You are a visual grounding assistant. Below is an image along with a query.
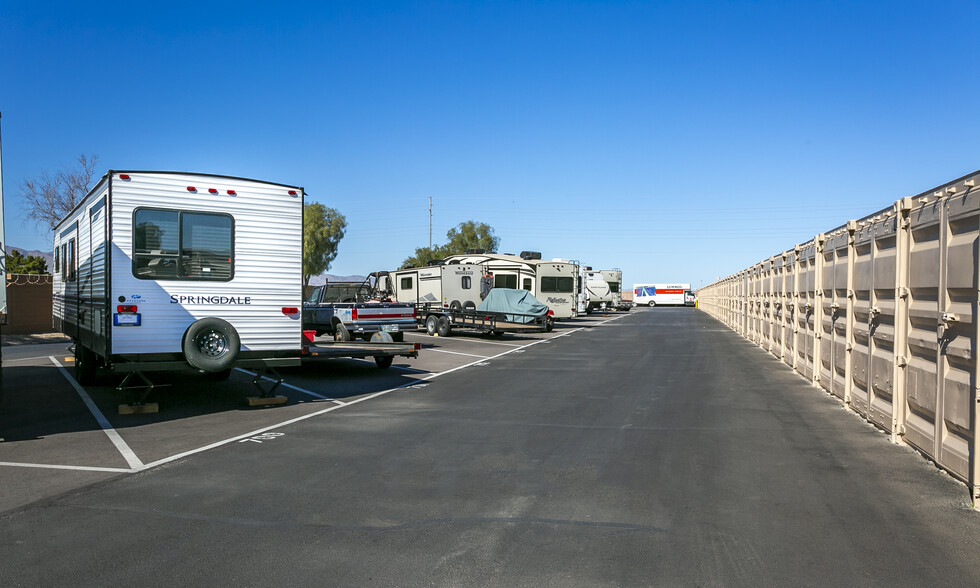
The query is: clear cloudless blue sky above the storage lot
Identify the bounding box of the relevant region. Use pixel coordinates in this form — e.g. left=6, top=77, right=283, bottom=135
left=0, top=0, right=980, bottom=287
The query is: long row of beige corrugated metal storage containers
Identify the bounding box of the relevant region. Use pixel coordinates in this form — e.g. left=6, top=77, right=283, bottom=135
left=698, top=171, right=980, bottom=505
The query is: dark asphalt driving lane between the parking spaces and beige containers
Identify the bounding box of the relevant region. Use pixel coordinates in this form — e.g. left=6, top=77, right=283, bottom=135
left=0, top=308, right=980, bottom=586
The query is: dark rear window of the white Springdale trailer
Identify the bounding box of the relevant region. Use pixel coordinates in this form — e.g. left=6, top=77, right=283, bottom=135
left=133, top=208, right=235, bottom=282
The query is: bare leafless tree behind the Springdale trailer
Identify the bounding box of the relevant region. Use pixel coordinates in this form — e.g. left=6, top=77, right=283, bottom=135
left=21, top=155, right=99, bottom=229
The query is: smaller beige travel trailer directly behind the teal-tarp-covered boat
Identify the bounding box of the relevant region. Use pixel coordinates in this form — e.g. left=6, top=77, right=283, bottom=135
left=378, top=262, right=493, bottom=310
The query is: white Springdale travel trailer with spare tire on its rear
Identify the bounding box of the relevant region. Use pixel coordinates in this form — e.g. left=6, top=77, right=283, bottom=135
left=53, top=171, right=305, bottom=383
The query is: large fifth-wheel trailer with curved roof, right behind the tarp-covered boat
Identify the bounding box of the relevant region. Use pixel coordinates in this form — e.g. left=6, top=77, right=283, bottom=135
left=445, top=251, right=578, bottom=319
